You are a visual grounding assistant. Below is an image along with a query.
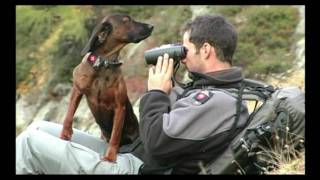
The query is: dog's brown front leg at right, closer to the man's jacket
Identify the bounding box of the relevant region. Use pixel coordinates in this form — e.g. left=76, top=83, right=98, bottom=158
left=103, top=106, right=126, bottom=162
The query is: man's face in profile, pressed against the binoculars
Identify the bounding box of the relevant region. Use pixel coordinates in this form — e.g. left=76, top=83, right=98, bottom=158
left=181, top=31, right=201, bottom=72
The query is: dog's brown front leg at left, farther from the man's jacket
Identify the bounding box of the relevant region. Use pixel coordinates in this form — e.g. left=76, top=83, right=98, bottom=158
left=60, top=84, right=83, bottom=140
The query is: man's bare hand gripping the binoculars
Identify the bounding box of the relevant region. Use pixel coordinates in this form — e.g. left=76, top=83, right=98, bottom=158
left=148, top=54, right=173, bottom=94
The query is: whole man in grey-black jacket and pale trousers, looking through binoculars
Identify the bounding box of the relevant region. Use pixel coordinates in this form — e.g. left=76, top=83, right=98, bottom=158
left=16, top=16, right=248, bottom=174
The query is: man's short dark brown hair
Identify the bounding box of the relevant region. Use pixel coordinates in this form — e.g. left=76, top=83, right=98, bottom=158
left=183, top=15, right=237, bottom=64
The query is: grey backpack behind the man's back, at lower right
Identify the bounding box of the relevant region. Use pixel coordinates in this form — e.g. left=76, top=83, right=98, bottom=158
left=200, top=79, right=305, bottom=174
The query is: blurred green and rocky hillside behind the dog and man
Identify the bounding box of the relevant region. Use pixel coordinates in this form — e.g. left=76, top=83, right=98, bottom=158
left=16, top=5, right=305, bottom=139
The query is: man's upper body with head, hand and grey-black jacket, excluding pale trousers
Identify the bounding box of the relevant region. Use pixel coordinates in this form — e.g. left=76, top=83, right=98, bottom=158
left=133, top=16, right=248, bottom=174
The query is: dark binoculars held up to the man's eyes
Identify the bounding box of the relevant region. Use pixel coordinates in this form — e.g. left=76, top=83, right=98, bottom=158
left=144, top=44, right=187, bottom=65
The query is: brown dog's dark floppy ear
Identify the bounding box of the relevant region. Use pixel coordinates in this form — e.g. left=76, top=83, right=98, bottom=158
left=81, top=21, right=112, bottom=56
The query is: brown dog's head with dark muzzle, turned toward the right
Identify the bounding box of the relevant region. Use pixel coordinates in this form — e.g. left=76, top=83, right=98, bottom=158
left=81, top=14, right=153, bottom=55
